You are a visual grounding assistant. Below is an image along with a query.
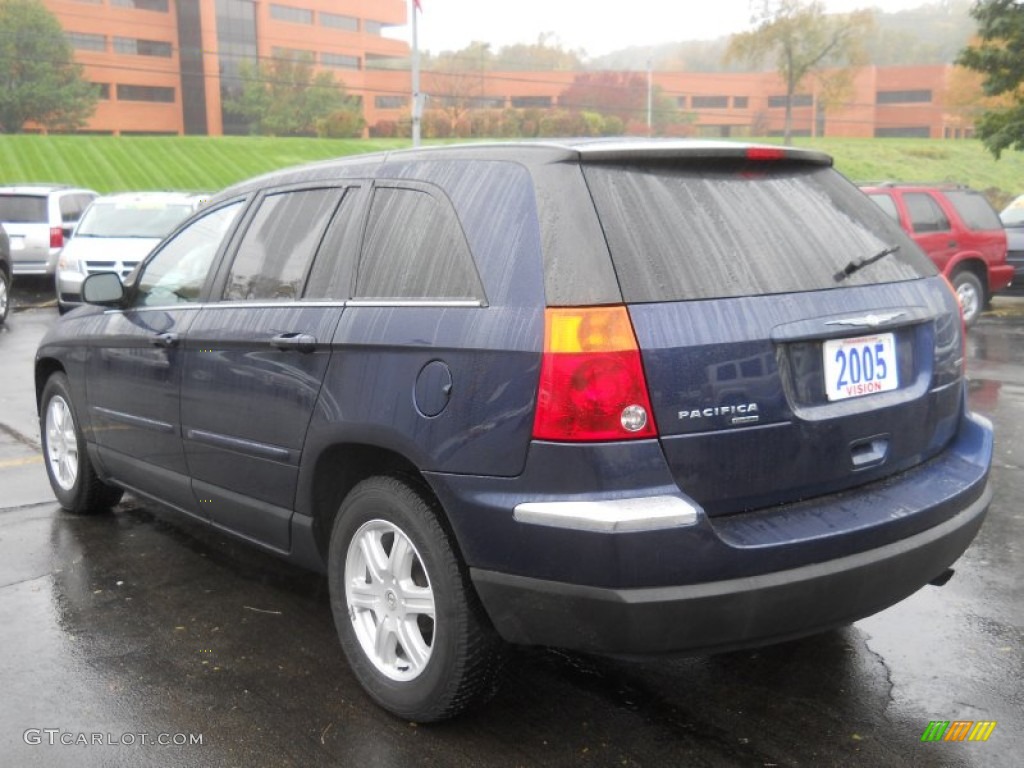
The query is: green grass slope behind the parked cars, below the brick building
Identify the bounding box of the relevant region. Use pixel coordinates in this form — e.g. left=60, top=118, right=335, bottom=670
left=0, top=135, right=1024, bottom=207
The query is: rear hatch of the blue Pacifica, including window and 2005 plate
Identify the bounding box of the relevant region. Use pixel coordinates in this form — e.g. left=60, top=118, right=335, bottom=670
left=583, top=147, right=963, bottom=515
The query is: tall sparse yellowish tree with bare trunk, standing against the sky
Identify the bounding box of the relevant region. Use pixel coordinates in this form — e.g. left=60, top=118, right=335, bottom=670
left=726, top=0, right=874, bottom=142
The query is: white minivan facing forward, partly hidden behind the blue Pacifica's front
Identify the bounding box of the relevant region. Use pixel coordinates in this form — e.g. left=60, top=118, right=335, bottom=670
left=55, top=191, right=205, bottom=313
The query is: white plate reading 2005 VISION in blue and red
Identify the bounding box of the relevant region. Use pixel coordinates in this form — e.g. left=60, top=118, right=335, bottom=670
left=822, top=334, right=899, bottom=400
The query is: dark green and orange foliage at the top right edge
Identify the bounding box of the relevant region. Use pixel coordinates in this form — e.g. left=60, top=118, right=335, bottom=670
left=957, top=0, right=1024, bottom=160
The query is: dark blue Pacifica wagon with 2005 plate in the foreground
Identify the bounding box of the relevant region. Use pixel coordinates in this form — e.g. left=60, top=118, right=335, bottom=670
left=36, top=140, right=992, bottom=721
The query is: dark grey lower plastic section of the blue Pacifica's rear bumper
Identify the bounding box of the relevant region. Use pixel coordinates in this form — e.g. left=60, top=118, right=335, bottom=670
left=471, top=485, right=991, bottom=654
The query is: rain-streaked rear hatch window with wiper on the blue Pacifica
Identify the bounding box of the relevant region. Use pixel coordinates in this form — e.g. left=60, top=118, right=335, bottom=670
left=584, top=161, right=935, bottom=302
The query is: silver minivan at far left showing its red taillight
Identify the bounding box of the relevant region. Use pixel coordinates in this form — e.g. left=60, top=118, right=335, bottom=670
left=0, top=184, right=97, bottom=276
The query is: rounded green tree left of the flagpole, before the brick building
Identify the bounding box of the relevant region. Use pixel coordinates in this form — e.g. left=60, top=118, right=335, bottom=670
left=224, top=54, right=362, bottom=136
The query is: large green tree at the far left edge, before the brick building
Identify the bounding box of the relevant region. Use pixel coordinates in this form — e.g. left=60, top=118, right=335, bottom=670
left=0, top=0, right=99, bottom=133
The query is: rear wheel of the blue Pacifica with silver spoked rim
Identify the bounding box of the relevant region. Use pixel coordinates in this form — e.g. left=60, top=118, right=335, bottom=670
left=328, top=476, right=502, bottom=722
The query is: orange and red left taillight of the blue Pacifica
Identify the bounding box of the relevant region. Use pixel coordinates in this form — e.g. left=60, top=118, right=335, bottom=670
left=534, top=306, right=657, bottom=441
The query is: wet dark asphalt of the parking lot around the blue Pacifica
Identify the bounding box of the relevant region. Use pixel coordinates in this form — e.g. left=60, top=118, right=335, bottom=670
left=0, top=285, right=1024, bottom=768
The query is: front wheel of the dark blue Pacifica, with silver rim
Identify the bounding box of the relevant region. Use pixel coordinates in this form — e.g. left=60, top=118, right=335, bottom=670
left=39, top=373, right=124, bottom=514
